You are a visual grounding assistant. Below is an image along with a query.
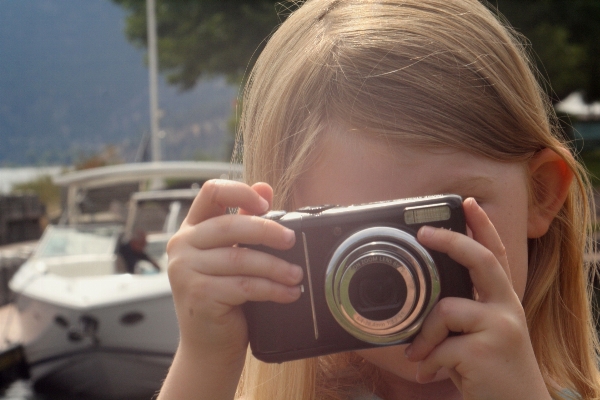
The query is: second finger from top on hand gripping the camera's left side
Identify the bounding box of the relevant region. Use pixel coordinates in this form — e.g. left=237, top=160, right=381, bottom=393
left=181, top=214, right=296, bottom=250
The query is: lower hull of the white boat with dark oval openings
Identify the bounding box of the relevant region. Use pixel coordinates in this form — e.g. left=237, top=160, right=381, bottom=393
left=17, top=278, right=179, bottom=399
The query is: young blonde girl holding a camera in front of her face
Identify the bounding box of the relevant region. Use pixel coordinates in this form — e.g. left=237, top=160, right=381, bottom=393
left=159, top=0, right=600, bottom=400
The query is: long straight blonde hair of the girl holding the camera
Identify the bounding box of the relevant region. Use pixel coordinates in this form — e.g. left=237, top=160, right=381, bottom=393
left=233, top=0, right=600, bottom=400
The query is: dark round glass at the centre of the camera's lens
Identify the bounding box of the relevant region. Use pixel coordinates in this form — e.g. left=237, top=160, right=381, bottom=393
left=348, top=263, right=406, bottom=321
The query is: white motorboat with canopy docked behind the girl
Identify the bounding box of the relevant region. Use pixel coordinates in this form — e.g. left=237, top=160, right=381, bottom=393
left=10, top=163, right=239, bottom=399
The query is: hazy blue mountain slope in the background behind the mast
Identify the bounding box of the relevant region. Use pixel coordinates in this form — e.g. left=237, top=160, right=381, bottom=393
left=0, top=0, right=238, bottom=166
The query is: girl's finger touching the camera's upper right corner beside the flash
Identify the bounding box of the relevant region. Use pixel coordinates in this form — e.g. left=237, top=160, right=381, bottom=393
left=463, top=198, right=512, bottom=282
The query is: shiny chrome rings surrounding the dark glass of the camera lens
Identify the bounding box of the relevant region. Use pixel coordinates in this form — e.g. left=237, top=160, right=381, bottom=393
left=325, top=227, right=440, bottom=344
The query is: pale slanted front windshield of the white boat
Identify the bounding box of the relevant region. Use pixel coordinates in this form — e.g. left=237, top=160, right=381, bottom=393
left=36, top=226, right=120, bottom=257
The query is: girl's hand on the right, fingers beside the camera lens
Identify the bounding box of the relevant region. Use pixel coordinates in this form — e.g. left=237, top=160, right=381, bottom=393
left=406, top=198, right=550, bottom=400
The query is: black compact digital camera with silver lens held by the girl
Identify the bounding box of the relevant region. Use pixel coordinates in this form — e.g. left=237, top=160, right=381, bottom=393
left=244, top=195, right=473, bottom=362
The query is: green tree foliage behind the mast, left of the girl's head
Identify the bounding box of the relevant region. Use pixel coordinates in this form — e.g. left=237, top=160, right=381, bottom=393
left=113, top=0, right=290, bottom=90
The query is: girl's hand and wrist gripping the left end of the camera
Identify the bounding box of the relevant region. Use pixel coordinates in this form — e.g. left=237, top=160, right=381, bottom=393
left=158, top=180, right=302, bottom=399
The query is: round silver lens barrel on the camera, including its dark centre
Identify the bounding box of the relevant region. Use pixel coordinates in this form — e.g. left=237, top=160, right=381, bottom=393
left=325, top=227, right=440, bottom=345
